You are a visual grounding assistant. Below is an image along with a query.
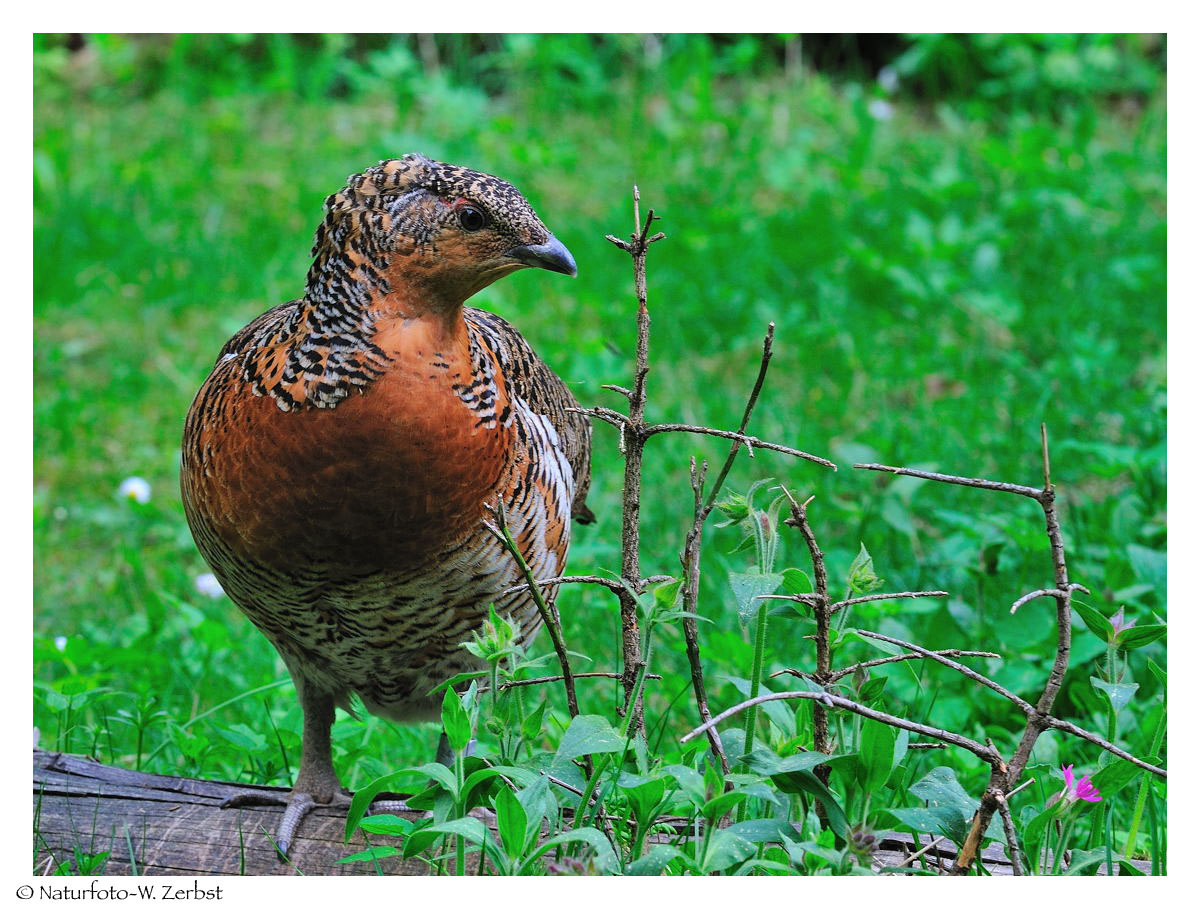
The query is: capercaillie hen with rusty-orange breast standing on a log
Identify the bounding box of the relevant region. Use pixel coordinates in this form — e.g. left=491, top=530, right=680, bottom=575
left=180, top=155, right=592, bottom=851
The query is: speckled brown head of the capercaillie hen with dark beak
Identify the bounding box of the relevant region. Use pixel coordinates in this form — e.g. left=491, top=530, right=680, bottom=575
left=308, top=155, right=576, bottom=308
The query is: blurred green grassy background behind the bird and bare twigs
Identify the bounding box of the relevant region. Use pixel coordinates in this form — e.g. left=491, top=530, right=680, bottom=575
left=34, top=35, right=1166, bottom=787
